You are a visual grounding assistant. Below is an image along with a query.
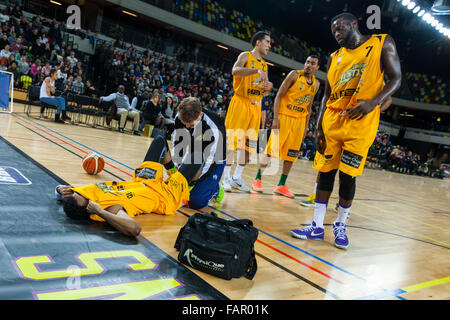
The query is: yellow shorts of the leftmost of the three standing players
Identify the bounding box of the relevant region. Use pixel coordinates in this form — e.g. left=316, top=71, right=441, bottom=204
left=225, top=95, right=261, bottom=153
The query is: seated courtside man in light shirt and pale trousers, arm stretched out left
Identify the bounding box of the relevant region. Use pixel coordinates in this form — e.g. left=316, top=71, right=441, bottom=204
left=100, top=85, right=141, bottom=136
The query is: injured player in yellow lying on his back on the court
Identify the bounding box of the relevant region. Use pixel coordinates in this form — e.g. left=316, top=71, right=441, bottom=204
left=55, top=136, right=202, bottom=237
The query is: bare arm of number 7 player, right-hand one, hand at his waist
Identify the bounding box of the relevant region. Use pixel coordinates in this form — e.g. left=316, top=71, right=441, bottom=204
left=347, top=35, right=402, bottom=120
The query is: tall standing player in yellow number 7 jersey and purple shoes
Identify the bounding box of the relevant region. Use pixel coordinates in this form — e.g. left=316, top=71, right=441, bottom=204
left=291, top=13, right=401, bottom=249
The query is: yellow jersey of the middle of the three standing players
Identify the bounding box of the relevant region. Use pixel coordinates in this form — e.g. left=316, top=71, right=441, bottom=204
left=279, top=70, right=316, bottom=118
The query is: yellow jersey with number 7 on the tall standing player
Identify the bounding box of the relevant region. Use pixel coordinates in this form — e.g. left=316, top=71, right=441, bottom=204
left=327, top=34, right=387, bottom=110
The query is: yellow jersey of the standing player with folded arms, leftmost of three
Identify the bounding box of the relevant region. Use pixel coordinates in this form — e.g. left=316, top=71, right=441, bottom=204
left=233, top=51, right=267, bottom=103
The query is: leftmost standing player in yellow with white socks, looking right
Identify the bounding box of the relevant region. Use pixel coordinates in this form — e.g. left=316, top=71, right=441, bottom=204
left=222, top=31, right=273, bottom=192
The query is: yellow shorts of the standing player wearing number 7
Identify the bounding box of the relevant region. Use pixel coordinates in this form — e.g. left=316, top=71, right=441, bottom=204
left=313, top=107, right=380, bottom=177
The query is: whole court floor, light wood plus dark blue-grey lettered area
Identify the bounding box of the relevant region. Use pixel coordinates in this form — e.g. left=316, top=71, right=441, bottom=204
left=0, top=103, right=450, bottom=300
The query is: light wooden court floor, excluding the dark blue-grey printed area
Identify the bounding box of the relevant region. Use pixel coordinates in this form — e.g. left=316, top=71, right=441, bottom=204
left=0, top=103, right=450, bottom=300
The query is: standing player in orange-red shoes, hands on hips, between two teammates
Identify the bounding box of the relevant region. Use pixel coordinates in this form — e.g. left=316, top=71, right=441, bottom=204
left=252, top=56, right=320, bottom=198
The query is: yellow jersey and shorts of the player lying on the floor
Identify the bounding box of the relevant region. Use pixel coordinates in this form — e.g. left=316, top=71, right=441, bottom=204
left=72, top=161, right=189, bottom=221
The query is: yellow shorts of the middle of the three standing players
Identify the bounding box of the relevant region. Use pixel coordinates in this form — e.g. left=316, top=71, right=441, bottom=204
left=264, top=114, right=306, bottom=162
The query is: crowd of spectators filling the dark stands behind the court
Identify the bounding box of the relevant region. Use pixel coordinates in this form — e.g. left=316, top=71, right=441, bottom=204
left=0, top=0, right=448, bottom=176
